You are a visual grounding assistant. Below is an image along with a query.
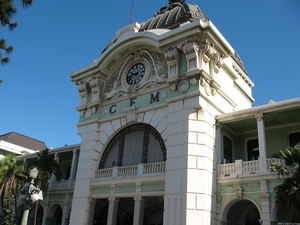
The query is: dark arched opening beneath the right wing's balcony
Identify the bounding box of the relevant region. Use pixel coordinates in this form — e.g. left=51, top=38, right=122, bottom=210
left=225, top=200, right=260, bottom=225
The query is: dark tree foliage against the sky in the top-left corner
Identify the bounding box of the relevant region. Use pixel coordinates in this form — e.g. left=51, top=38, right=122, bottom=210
left=0, top=0, right=33, bottom=65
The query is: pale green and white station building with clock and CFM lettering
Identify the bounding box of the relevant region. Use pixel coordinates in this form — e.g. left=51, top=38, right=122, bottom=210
left=5, top=0, right=300, bottom=225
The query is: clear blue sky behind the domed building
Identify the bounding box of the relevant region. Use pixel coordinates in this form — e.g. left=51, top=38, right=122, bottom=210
left=0, top=0, right=300, bottom=148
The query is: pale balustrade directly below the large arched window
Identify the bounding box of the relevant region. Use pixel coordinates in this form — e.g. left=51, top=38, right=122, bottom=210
left=95, top=162, right=166, bottom=180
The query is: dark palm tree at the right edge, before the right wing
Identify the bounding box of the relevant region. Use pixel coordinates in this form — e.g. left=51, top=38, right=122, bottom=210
left=270, top=144, right=300, bottom=223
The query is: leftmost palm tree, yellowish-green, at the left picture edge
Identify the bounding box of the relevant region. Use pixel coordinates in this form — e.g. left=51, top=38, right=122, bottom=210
left=0, top=155, right=27, bottom=224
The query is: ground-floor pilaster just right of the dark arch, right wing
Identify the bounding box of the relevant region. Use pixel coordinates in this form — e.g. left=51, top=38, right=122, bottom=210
left=260, top=180, right=271, bottom=225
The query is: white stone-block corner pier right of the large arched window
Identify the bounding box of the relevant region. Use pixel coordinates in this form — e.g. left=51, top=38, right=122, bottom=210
left=164, top=97, right=214, bottom=225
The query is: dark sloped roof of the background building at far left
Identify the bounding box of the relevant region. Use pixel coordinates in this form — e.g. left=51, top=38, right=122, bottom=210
left=0, top=132, right=47, bottom=150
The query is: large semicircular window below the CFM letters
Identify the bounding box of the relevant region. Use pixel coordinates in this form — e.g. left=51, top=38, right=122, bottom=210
left=99, top=124, right=166, bottom=169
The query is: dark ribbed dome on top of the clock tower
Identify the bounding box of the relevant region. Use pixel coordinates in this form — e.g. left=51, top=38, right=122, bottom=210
left=139, top=0, right=208, bottom=31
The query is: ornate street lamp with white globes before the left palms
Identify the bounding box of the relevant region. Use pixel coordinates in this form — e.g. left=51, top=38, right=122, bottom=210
left=21, top=167, right=42, bottom=225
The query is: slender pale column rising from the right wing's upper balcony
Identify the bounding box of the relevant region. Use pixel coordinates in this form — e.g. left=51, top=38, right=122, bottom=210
left=255, top=113, right=268, bottom=173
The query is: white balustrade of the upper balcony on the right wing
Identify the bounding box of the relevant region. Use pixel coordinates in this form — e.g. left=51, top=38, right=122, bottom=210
left=218, top=158, right=281, bottom=178
